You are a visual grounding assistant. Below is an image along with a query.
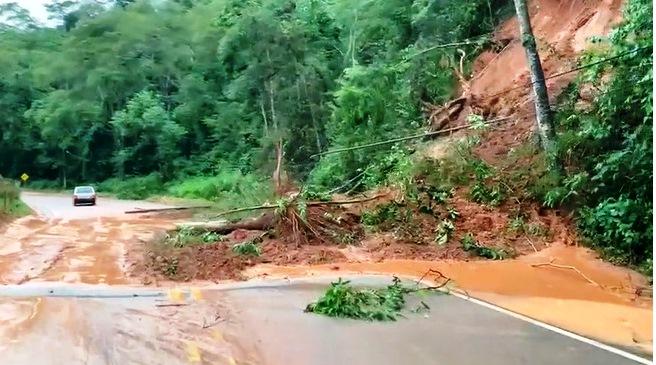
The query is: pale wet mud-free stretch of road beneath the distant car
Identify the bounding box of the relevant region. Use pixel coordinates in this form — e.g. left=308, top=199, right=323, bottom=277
left=21, top=191, right=172, bottom=220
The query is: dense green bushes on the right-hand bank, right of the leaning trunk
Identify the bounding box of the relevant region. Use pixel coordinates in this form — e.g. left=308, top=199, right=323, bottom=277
left=542, top=0, right=653, bottom=276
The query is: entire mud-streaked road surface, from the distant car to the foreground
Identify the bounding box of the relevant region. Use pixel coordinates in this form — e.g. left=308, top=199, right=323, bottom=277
left=0, top=193, right=649, bottom=365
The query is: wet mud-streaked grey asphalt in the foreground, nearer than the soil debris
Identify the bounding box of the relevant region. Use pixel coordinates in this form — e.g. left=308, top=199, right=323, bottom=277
left=0, top=277, right=638, bottom=365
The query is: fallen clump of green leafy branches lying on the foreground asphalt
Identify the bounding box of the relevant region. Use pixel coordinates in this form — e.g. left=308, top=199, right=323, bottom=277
left=305, top=270, right=450, bottom=321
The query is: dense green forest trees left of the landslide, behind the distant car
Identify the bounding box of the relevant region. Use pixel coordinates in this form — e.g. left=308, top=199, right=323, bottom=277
left=0, top=0, right=506, bottom=182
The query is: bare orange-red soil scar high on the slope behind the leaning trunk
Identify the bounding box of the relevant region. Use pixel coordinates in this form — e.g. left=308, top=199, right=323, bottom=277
left=436, top=0, right=622, bottom=163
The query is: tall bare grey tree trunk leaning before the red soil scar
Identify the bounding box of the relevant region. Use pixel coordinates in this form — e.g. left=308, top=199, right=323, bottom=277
left=514, top=0, right=555, bottom=154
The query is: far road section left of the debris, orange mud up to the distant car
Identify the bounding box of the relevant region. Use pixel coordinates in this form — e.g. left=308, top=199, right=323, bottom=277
left=0, top=192, right=171, bottom=284
